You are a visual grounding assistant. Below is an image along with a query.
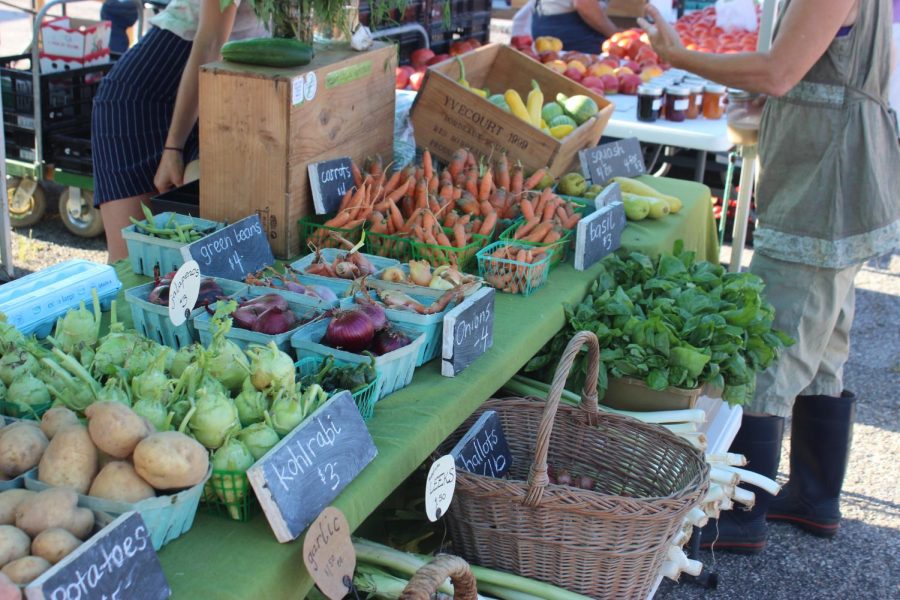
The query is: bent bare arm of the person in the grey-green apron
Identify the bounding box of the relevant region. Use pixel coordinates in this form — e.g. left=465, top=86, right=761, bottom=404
left=638, top=0, right=858, bottom=96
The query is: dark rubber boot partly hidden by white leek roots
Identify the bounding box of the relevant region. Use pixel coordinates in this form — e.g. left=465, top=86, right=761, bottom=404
left=700, top=415, right=784, bottom=554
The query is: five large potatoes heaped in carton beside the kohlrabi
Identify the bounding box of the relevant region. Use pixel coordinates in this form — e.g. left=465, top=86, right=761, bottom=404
left=34, top=402, right=209, bottom=502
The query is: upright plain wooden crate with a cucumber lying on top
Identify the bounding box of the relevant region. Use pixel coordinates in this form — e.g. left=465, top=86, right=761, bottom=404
left=200, top=42, right=397, bottom=258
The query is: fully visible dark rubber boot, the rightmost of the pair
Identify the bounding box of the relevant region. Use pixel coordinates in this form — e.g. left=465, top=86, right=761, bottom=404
left=768, top=391, right=856, bottom=538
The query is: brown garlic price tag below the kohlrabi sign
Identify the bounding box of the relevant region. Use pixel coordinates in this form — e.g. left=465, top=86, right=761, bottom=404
left=303, top=506, right=356, bottom=600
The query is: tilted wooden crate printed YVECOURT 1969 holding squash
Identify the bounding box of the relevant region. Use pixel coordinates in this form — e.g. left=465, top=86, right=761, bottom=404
left=410, top=44, right=613, bottom=176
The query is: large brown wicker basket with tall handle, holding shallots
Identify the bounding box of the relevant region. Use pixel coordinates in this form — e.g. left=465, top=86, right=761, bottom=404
left=442, top=331, right=709, bottom=600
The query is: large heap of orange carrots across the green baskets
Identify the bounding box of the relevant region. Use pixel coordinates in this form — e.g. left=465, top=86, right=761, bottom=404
left=312, top=148, right=577, bottom=260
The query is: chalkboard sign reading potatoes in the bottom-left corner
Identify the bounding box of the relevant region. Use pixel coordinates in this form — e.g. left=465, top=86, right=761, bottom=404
left=25, top=511, right=172, bottom=600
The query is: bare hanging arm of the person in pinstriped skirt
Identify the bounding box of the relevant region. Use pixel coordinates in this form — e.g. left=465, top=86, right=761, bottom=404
left=153, top=0, right=237, bottom=192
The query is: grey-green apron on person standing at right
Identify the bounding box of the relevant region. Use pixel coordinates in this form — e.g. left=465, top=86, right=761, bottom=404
left=754, top=0, right=900, bottom=269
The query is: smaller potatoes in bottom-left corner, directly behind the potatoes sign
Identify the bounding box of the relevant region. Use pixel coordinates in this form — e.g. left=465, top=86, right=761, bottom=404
left=0, top=488, right=94, bottom=599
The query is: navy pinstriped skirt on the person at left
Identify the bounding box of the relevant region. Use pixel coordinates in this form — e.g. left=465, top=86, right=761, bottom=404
left=91, top=28, right=199, bottom=206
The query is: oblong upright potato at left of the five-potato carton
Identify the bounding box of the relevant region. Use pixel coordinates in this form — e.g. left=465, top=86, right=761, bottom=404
left=38, top=425, right=97, bottom=494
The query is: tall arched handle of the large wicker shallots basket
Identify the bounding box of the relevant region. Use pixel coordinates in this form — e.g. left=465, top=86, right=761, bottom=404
left=525, top=331, right=600, bottom=506
